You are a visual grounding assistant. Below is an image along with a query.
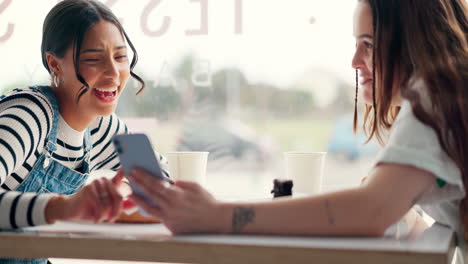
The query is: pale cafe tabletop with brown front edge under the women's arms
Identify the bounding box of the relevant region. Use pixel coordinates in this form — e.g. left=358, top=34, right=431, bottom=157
left=0, top=219, right=455, bottom=264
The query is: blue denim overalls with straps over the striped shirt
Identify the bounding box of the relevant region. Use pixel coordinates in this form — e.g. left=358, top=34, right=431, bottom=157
left=0, top=86, right=92, bottom=264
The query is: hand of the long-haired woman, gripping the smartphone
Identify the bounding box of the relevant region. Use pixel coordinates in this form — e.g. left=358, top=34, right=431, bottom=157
left=126, top=169, right=225, bottom=234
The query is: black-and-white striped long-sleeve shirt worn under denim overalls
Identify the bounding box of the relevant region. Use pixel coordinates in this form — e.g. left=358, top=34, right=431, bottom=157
left=0, top=88, right=167, bottom=229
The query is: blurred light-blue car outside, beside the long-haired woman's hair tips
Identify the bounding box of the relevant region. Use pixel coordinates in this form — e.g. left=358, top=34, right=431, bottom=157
left=327, top=115, right=379, bottom=160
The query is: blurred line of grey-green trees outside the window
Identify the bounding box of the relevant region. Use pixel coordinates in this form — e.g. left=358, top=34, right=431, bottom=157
left=117, top=54, right=326, bottom=120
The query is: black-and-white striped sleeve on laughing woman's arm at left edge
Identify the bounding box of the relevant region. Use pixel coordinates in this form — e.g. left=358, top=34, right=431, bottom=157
left=0, top=93, right=54, bottom=229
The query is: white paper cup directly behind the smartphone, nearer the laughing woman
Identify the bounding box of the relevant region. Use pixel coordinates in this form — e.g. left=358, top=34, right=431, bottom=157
left=167, top=152, right=209, bottom=185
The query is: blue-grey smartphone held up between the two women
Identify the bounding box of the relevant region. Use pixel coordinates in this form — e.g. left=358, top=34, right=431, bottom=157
left=112, top=134, right=173, bottom=207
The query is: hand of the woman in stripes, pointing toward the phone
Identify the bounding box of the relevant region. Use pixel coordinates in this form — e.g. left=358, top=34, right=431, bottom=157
left=45, top=173, right=123, bottom=224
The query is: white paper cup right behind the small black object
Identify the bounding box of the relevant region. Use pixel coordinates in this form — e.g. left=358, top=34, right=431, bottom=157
left=284, top=152, right=327, bottom=195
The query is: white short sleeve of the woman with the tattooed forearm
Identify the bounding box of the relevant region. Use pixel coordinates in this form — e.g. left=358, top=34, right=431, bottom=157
left=377, top=100, right=465, bottom=203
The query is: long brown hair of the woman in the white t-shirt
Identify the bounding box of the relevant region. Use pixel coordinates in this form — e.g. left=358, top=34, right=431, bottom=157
left=356, top=0, right=468, bottom=235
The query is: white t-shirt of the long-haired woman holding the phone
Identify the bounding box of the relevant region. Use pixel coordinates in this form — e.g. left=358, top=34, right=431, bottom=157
left=376, top=80, right=465, bottom=232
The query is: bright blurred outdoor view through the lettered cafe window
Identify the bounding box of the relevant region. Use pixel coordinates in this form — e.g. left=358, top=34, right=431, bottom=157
left=0, top=0, right=378, bottom=197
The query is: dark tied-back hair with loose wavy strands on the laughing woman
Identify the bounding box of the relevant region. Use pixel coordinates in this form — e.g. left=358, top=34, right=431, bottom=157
left=41, top=0, right=145, bottom=100
